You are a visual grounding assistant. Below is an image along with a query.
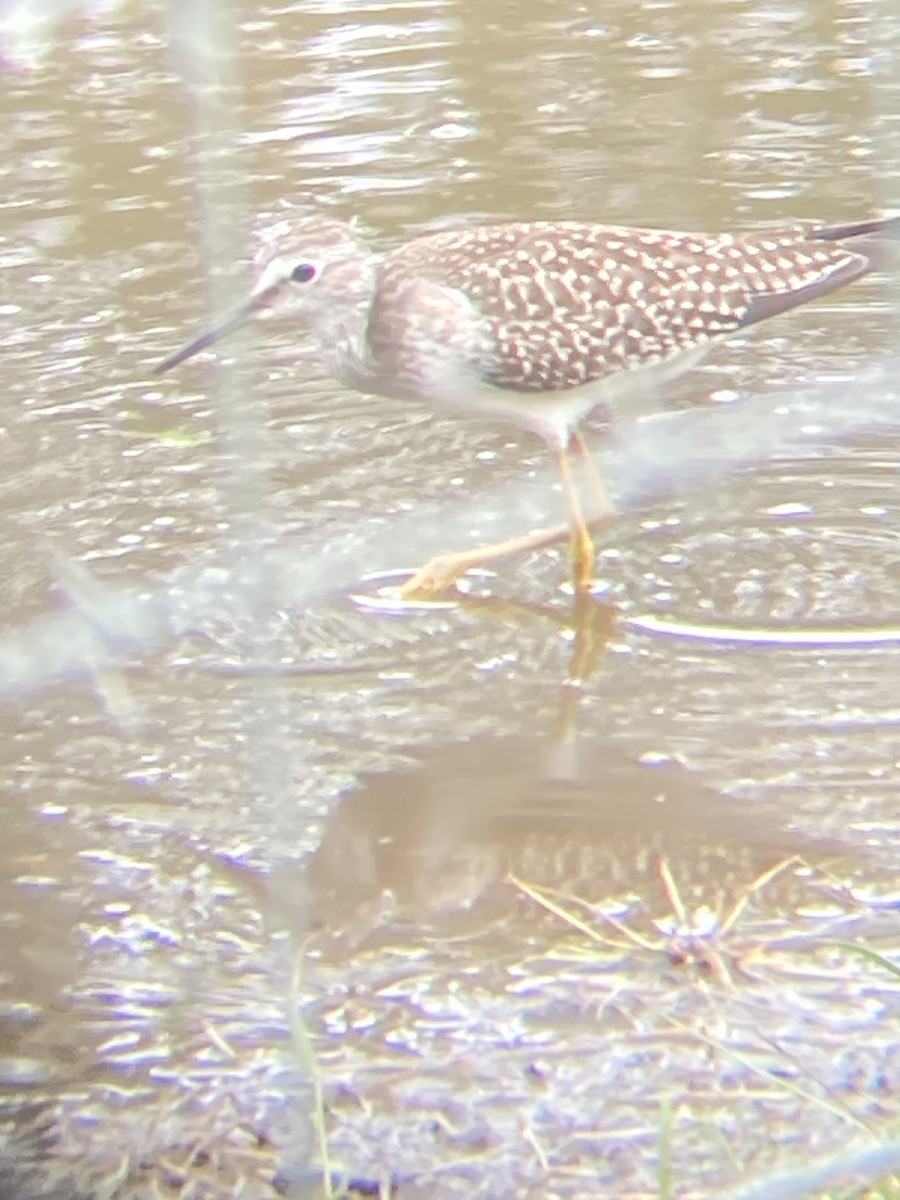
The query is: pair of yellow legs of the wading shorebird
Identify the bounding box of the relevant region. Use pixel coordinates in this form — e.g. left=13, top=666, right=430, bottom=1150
left=401, top=434, right=616, bottom=600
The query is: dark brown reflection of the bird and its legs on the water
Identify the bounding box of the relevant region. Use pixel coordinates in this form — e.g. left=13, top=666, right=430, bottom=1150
left=289, top=598, right=846, bottom=960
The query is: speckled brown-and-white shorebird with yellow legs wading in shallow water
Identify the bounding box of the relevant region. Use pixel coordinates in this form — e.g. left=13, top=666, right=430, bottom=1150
left=156, top=216, right=900, bottom=599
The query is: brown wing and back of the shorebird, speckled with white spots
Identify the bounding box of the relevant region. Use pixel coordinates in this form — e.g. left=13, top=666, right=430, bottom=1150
left=368, top=222, right=871, bottom=391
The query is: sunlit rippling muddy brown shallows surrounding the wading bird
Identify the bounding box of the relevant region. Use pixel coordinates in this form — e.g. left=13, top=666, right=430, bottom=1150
left=0, top=0, right=900, bottom=1198
